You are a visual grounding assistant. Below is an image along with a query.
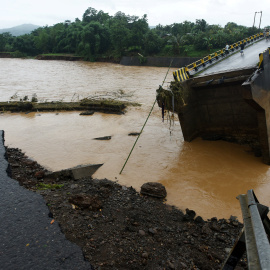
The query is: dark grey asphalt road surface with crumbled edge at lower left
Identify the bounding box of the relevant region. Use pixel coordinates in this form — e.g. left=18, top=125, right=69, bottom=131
left=0, top=130, right=92, bottom=270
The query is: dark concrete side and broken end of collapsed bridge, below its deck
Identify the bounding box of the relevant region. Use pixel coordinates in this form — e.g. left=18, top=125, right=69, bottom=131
left=157, top=36, right=270, bottom=164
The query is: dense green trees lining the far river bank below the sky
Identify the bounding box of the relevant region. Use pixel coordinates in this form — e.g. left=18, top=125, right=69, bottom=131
left=0, top=7, right=266, bottom=61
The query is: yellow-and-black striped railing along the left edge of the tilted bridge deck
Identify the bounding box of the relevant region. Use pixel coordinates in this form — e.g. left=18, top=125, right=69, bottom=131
left=173, top=33, right=264, bottom=81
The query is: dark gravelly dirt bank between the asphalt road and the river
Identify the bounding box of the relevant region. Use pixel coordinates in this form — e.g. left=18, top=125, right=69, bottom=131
left=7, top=148, right=247, bottom=270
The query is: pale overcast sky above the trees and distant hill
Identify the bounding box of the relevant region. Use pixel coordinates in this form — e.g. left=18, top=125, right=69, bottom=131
left=0, top=0, right=270, bottom=29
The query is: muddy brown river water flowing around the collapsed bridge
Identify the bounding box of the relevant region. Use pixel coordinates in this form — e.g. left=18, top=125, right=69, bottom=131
left=0, top=59, right=270, bottom=220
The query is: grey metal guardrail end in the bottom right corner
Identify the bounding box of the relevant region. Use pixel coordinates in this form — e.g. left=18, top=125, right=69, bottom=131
left=221, top=189, right=270, bottom=270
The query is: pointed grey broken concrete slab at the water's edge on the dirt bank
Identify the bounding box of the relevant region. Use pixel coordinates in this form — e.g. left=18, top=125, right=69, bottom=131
left=45, top=164, right=103, bottom=180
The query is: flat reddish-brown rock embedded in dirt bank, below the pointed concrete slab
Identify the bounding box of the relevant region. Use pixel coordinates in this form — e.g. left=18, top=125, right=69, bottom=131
left=68, top=194, right=102, bottom=211
